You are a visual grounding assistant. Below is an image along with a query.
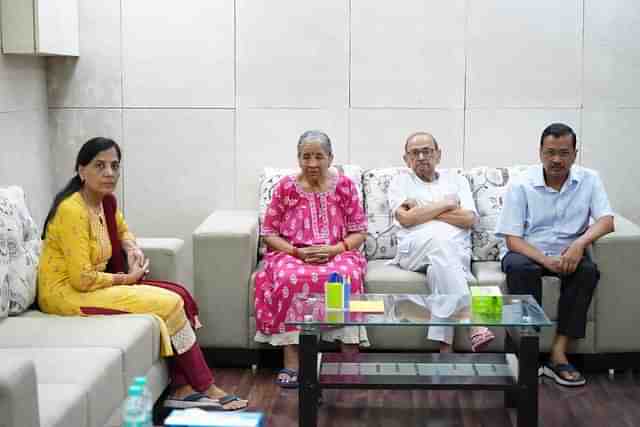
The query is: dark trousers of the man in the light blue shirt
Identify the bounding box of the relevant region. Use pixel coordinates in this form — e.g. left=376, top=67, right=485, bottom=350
left=502, top=252, right=600, bottom=338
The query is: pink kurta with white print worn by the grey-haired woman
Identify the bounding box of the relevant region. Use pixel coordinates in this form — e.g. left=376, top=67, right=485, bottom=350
left=255, top=175, right=367, bottom=335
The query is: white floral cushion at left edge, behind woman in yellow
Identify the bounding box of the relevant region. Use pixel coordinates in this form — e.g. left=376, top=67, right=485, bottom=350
left=0, top=187, right=41, bottom=318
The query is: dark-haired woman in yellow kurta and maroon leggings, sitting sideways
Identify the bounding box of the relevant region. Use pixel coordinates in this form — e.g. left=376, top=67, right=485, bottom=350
left=38, top=138, right=247, bottom=410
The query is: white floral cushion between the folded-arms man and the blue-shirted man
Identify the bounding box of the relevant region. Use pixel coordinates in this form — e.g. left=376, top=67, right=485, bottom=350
left=464, top=165, right=529, bottom=261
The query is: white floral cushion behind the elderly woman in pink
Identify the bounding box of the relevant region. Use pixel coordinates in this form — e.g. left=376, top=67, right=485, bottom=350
left=258, top=165, right=363, bottom=257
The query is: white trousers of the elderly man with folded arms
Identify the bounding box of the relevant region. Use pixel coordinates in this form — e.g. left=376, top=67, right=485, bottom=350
left=395, top=227, right=471, bottom=344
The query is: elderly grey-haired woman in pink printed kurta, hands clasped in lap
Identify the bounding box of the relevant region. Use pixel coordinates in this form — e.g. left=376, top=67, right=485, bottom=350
left=255, top=131, right=368, bottom=388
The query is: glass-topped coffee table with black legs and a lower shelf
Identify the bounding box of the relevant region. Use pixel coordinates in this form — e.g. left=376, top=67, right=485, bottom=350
left=286, top=294, right=552, bottom=427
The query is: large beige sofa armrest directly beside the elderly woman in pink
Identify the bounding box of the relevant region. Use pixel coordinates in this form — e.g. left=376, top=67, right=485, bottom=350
left=193, top=210, right=258, bottom=348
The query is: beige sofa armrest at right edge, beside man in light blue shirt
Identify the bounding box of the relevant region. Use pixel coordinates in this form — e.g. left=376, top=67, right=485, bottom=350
left=592, top=215, right=640, bottom=353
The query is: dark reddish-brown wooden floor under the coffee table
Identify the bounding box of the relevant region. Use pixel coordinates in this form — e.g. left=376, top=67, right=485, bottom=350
left=206, top=368, right=640, bottom=427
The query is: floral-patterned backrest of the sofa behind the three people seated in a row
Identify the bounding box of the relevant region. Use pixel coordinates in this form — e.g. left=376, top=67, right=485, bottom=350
left=255, top=165, right=529, bottom=261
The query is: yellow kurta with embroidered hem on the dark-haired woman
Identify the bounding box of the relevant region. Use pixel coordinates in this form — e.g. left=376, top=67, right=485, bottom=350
left=38, top=193, right=195, bottom=356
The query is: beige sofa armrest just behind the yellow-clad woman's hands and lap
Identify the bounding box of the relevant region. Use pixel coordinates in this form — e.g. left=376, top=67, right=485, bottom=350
left=137, top=238, right=184, bottom=282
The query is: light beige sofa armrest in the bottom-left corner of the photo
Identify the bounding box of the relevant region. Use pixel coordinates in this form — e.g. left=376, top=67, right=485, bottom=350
left=0, top=358, right=40, bottom=427
